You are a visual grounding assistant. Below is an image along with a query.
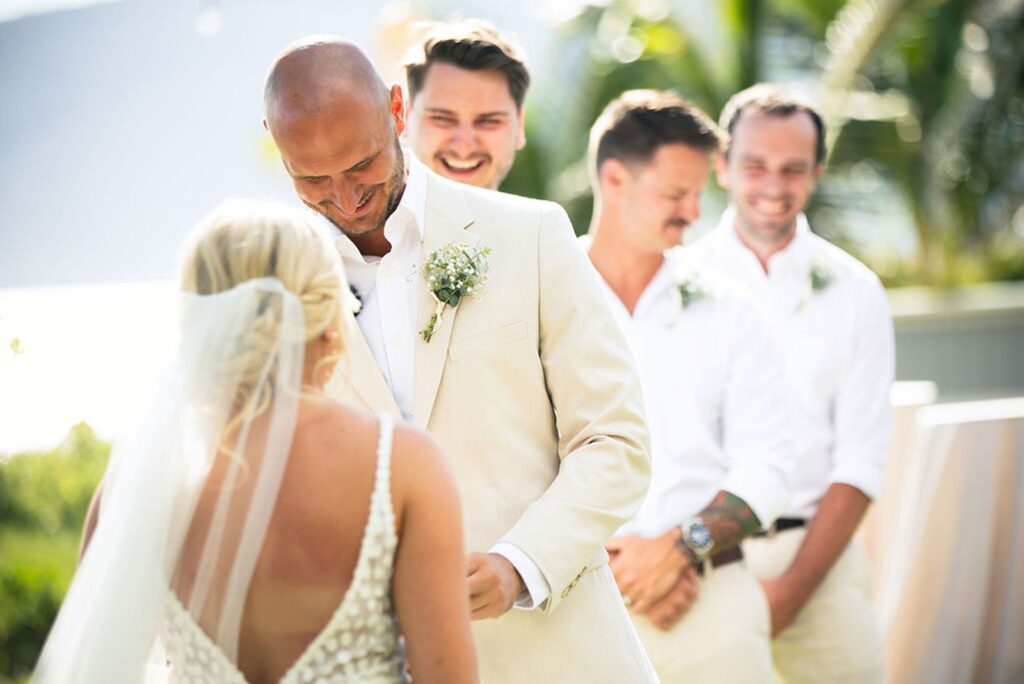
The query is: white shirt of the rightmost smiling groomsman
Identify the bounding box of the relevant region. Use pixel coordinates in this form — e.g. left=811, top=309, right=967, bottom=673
left=689, top=209, right=894, bottom=518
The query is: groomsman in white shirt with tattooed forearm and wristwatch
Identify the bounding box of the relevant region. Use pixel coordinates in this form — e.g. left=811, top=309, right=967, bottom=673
left=588, top=90, right=794, bottom=684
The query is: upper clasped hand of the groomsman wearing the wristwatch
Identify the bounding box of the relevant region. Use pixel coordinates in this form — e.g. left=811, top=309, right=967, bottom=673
left=605, top=529, right=690, bottom=614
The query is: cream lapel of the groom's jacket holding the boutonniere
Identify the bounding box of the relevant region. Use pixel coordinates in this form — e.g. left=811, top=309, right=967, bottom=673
left=413, top=179, right=479, bottom=428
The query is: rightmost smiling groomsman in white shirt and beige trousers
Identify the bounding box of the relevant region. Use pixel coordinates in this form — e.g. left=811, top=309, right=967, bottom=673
left=693, top=85, right=894, bottom=682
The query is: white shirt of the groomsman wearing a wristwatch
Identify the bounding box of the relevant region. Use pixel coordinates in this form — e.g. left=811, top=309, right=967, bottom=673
left=601, top=249, right=795, bottom=538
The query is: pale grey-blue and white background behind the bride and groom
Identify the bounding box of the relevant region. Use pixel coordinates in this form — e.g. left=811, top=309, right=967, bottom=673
left=0, top=0, right=561, bottom=455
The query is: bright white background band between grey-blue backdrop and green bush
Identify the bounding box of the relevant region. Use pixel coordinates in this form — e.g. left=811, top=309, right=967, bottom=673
left=0, top=282, right=176, bottom=455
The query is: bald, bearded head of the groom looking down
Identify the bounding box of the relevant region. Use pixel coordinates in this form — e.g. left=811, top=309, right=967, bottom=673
left=263, top=36, right=406, bottom=245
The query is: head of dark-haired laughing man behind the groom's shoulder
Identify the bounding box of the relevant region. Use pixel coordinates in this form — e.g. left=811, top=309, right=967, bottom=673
left=404, top=20, right=529, bottom=189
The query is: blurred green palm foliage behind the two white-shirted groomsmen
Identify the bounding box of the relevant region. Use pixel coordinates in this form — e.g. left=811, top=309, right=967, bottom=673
left=503, top=0, right=1024, bottom=286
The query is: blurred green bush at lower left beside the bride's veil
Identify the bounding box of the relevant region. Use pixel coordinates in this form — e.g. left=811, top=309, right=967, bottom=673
left=0, top=424, right=110, bottom=682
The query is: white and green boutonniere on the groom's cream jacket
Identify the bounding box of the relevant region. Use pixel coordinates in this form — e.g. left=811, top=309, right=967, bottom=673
left=420, top=243, right=490, bottom=342
